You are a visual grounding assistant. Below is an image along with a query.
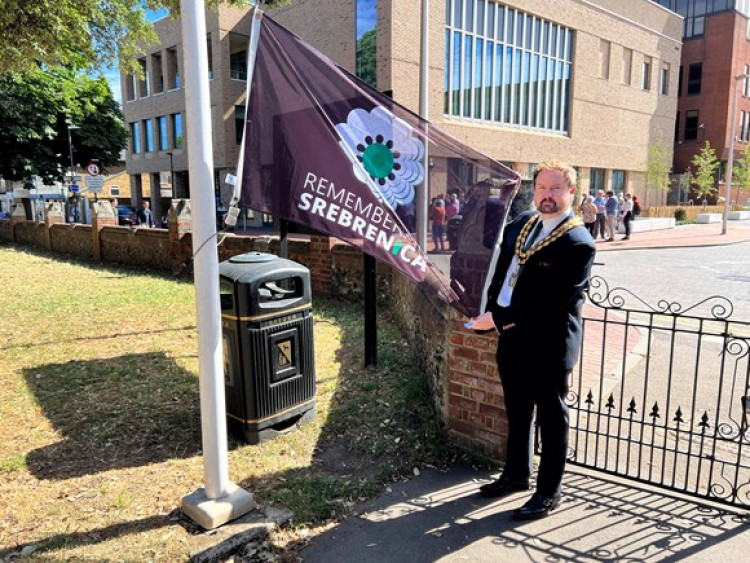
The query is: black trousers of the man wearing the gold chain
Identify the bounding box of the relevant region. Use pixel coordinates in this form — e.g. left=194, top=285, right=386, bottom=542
left=497, top=348, right=570, bottom=497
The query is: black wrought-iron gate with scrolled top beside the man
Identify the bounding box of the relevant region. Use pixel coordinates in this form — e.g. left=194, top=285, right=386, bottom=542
left=567, top=276, right=750, bottom=508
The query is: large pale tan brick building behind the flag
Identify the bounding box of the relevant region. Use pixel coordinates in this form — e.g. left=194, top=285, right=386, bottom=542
left=122, top=0, right=683, bottom=209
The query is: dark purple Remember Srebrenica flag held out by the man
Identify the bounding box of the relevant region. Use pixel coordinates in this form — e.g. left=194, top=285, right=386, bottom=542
left=240, top=15, right=519, bottom=316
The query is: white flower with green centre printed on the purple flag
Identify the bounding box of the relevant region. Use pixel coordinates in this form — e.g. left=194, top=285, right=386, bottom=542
left=336, top=106, right=424, bottom=209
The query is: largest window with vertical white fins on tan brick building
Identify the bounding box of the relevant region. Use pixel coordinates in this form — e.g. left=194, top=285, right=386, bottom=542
left=443, top=0, right=574, bottom=133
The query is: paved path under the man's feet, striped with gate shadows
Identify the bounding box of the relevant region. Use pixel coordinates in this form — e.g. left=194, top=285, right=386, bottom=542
left=300, top=466, right=750, bottom=563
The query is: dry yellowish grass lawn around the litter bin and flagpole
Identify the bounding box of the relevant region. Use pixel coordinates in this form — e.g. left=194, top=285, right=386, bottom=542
left=0, top=246, right=470, bottom=561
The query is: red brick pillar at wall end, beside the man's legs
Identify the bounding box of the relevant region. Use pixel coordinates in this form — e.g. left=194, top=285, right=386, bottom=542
left=447, top=315, right=508, bottom=461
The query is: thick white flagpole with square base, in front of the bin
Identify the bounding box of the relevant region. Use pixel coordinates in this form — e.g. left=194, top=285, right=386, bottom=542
left=180, top=0, right=255, bottom=529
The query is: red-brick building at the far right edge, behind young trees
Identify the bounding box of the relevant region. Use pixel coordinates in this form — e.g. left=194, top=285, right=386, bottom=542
left=654, top=0, right=750, bottom=207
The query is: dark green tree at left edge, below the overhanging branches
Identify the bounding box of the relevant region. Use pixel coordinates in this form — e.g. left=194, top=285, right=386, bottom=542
left=0, top=69, right=128, bottom=184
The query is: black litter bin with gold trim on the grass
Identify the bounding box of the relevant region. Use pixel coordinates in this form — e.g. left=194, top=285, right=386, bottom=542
left=219, top=252, right=315, bottom=444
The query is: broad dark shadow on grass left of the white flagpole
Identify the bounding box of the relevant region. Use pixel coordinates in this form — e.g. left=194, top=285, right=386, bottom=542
left=24, top=353, right=200, bottom=479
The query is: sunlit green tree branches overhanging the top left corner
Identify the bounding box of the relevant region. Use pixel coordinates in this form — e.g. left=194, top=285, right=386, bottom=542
left=0, top=0, right=288, bottom=73
